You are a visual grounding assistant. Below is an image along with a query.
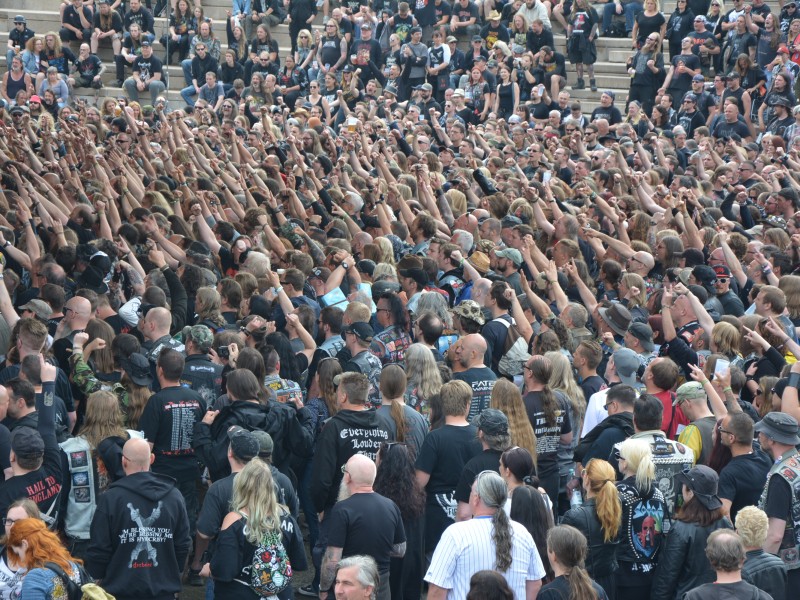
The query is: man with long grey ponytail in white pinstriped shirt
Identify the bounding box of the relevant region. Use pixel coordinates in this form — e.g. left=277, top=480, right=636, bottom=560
left=425, top=471, right=545, bottom=600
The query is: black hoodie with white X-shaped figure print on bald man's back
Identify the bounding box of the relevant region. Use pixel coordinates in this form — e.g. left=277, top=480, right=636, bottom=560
left=86, top=472, right=191, bottom=600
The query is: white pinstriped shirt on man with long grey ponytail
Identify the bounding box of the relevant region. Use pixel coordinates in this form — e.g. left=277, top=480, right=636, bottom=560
left=425, top=517, right=545, bottom=600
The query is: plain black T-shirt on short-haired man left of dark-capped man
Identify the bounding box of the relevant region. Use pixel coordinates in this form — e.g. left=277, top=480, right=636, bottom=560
left=416, top=425, right=481, bottom=500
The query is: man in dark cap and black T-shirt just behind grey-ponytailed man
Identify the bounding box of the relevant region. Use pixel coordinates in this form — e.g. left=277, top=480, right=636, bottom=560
left=455, top=408, right=511, bottom=521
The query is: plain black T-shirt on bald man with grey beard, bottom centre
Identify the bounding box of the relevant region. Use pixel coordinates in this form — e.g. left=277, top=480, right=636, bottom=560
left=325, top=492, right=406, bottom=573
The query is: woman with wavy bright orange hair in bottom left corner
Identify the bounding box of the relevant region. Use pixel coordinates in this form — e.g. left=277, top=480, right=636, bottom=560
left=6, top=518, right=89, bottom=600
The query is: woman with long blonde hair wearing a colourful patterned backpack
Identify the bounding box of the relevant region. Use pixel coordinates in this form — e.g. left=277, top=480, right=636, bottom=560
left=200, top=458, right=307, bottom=600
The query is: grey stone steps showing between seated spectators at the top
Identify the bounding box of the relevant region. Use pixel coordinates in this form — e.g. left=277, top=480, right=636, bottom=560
left=0, top=0, right=780, bottom=113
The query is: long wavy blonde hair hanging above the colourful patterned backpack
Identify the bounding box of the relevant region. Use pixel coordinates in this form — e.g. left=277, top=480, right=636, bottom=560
left=231, top=458, right=281, bottom=544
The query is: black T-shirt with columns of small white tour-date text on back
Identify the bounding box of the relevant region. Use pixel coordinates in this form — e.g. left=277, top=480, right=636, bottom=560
left=139, top=386, right=205, bottom=481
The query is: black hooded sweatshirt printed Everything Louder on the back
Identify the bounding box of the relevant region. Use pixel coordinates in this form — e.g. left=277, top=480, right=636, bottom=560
left=311, top=410, right=391, bottom=512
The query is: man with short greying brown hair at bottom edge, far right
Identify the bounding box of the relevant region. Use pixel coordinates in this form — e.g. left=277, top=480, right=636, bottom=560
left=683, top=529, right=772, bottom=600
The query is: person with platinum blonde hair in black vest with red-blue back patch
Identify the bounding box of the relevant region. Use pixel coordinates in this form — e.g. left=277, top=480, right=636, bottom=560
left=615, top=438, right=669, bottom=598
